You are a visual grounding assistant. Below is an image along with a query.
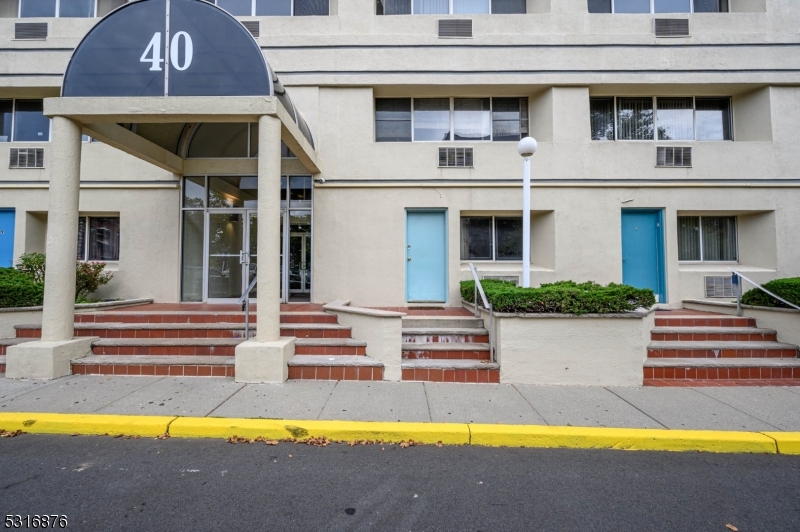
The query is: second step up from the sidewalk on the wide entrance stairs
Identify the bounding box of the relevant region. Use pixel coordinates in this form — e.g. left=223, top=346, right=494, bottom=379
left=92, top=338, right=367, bottom=356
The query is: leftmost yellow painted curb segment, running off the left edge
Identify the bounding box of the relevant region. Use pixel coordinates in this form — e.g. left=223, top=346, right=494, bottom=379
left=0, top=412, right=175, bottom=436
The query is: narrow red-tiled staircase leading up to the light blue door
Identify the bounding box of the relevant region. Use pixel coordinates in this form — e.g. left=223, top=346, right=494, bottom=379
left=401, top=316, right=500, bottom=383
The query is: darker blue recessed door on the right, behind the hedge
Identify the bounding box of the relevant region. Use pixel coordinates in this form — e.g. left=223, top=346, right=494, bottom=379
left=622, top=209, right=666, bottom=303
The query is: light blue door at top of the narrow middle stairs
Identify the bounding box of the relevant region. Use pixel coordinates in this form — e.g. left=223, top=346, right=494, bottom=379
left=406, top=211, right=447, bottom=303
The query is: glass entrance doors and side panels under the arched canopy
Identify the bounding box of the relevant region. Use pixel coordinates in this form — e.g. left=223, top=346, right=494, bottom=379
left=181, top=176, right=312, bottom=303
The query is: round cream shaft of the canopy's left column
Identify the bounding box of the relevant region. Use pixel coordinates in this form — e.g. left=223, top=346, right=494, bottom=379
left=42, top=116, right=83, bottom=342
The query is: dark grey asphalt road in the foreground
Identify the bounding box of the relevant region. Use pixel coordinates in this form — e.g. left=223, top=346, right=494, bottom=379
left=0, top=434, right=800, bottom=532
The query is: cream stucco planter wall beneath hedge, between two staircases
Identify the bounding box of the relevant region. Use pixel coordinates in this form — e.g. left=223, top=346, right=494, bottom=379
left=464, top=302, right=655, bottom=386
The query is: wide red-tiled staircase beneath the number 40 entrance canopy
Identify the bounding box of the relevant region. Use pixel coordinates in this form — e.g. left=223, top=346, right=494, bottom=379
left=0, top=311, right=383, bottom=380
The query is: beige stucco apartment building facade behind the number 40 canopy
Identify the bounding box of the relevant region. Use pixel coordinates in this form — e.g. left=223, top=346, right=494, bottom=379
left=0, top=0, right=800, bottom=314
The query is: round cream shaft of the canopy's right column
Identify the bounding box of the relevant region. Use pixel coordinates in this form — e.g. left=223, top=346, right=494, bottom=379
left=256, top=116, right=281, bottom=342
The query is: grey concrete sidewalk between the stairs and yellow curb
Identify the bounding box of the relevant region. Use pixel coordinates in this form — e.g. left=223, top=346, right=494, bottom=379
left=0, top=375, right=800, bottom=432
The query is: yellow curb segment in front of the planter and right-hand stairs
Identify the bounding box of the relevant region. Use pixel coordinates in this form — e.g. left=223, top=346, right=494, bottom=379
left=470, top=425, right=776, bottom=454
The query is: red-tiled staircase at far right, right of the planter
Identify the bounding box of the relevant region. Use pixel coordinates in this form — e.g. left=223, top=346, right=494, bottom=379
left=644, top=311, right=800, bottom=386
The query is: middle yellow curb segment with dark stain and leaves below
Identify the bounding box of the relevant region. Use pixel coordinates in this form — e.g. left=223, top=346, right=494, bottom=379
left=169, top=417, right=469, bottom=445
